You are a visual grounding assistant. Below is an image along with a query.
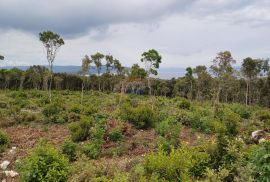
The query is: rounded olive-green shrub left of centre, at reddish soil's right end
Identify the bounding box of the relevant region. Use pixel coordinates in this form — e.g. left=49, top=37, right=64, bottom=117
left=69, top=118, right=93, bottom=142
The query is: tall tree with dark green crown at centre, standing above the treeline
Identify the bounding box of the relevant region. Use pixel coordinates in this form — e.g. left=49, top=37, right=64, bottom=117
left=141, top=49, right=162, bottom=95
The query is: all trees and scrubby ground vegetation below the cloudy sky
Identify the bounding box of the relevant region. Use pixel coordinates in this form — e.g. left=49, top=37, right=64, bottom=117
left=0, top=31, right=270, bottom=182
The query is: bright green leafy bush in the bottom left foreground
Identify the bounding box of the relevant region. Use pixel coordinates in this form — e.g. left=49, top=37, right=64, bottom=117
left=19, top=142, right=68, bottom=182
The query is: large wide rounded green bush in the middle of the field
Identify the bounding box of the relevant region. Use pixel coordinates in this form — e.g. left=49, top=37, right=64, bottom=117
left=121, top=105, right=156, bottom=129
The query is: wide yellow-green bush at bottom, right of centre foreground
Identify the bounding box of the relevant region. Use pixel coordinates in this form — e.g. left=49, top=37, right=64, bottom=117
left=145, top=145, right=208, bottom=182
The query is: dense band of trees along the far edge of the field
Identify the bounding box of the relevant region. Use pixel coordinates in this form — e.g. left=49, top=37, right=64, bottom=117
left=0, top=51, right=270, bottom=107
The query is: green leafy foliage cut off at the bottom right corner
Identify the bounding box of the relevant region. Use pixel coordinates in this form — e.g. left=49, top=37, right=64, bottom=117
left=251, top=141, right=270, bottom=182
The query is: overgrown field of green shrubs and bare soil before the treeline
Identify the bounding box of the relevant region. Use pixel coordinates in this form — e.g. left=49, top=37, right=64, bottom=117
left=0, top=90, right=270, bottom=182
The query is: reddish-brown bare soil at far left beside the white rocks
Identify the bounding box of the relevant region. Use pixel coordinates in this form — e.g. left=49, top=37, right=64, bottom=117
left=0, top=125, right=70, bottom=182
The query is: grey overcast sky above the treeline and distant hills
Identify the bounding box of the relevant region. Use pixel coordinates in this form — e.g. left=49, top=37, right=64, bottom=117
left=0, top=0, right=270, bottom=68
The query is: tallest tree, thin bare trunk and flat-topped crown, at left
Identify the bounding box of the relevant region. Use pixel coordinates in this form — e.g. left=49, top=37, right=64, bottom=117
left=39, top=31, right=65, bottom=102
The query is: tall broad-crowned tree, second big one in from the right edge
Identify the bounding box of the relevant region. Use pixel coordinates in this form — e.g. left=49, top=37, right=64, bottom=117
left=210, top=51, right=236, bottom=105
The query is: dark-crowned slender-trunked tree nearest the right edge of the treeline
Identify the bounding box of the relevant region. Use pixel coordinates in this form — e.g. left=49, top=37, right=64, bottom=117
left=241, top=57, right=263, bottom=105
